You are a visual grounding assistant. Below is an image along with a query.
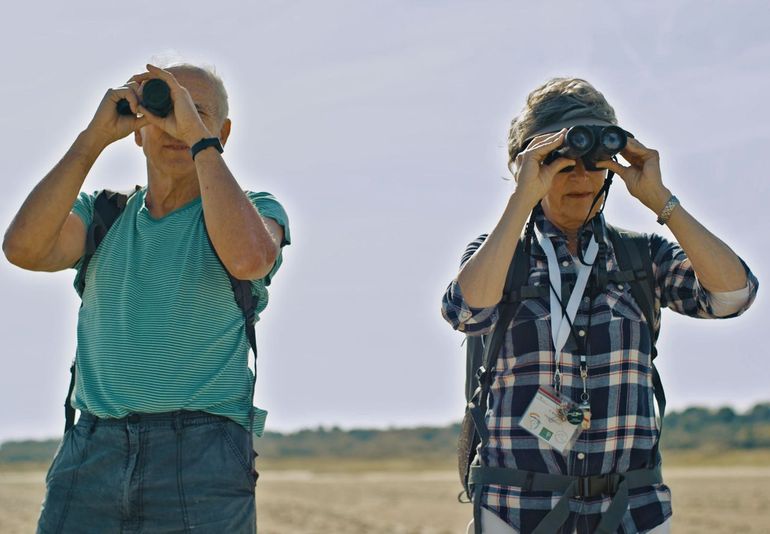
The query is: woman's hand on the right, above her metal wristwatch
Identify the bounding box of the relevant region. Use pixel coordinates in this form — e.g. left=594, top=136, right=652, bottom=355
left=596, top=137, right=671, bottom=215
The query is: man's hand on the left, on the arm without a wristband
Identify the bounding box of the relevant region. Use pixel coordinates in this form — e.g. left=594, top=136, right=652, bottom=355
left=84, top=81, right=147, bottom=148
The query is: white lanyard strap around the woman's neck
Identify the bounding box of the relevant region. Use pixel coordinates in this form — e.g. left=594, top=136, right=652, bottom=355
left=535, top=228, right=599, bottom=386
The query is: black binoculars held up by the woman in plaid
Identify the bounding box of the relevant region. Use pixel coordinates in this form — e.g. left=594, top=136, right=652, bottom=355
left=543, top=124, right=633, bottom=172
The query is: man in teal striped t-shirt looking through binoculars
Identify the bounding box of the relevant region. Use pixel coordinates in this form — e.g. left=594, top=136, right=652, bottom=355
left=3, top=64, right=290, bottom=533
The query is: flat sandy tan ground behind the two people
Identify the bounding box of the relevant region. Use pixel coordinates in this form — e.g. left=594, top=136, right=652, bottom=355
left=0, top=467, right=770, bottom=534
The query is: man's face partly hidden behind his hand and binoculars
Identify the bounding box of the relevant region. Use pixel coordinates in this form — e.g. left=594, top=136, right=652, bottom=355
left=134, top=68, right=229, bottom=177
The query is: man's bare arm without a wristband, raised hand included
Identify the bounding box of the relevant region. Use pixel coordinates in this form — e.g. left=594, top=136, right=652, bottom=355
left=3, top=83, right=146, bottom=271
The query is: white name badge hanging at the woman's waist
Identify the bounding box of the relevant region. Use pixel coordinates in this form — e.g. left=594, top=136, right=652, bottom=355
left=519, top=386, right=584, bottom=454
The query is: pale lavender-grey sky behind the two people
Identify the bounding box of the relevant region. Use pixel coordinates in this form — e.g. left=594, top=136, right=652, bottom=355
left=0, top=0, right=770, bottom=441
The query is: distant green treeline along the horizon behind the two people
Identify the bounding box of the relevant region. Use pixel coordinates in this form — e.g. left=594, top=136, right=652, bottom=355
left=0, top=402, right=770, bottom=463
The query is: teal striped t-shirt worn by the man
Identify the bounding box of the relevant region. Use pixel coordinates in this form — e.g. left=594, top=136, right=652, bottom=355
left=72, top=188, right=291, bottom=435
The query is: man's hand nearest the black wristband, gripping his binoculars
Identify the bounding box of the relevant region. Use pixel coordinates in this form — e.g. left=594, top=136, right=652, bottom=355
left=131, top=64, right=214, bottom=146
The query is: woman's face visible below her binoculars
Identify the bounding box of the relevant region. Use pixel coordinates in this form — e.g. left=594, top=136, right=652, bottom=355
left=542, top=159, right=607, bottom=232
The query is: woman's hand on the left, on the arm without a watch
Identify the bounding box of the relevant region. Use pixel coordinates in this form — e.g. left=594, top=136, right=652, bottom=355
left=512, top=128, right=575, bottom=207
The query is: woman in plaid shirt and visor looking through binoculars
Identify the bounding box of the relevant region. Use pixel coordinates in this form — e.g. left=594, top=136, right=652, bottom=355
left=442, top=78, right=758, bottom=534
